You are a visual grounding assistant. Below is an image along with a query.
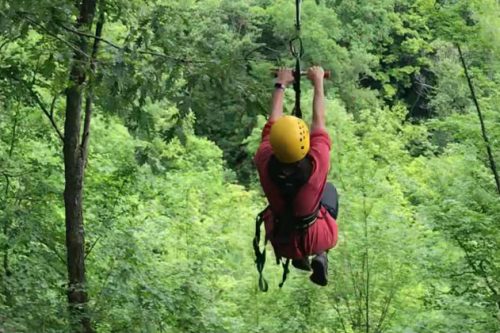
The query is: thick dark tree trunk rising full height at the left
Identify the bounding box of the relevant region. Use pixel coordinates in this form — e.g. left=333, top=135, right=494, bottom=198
left=63, top=0, right=96, bottom=333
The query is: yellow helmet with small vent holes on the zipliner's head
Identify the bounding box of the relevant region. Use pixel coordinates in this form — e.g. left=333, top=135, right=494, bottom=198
left=270, top=116, right=309, bottom=163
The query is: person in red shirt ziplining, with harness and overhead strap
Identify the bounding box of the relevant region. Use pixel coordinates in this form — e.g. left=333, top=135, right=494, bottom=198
left=253, top=0, right=338, bottom=291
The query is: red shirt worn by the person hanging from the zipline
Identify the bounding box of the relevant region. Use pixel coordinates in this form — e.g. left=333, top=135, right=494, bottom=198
left=254, top=121, right=338, bottom=259
